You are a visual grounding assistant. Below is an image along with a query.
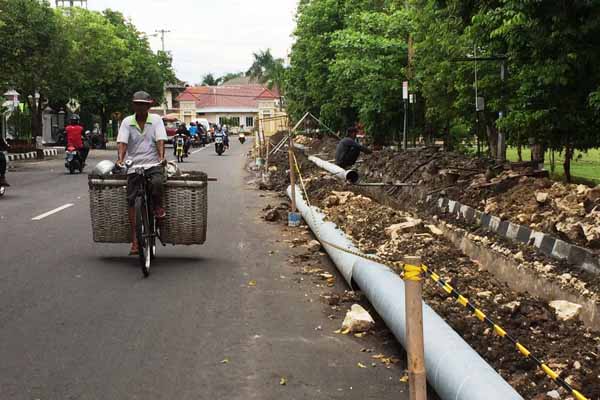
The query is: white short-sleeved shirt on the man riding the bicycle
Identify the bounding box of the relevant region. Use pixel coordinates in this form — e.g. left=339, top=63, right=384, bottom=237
left=117, top=113, right=168, bottom=173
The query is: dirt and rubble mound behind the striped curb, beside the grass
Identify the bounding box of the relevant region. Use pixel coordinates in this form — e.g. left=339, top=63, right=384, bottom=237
left=300, top=138, right=600, bottom=251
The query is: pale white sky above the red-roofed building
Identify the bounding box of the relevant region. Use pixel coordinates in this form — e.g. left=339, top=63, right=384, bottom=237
left=88, top=0, right=298, bottom=84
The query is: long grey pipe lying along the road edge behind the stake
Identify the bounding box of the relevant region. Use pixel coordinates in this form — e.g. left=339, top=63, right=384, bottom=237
left=287, top=187, right=523, bottom=400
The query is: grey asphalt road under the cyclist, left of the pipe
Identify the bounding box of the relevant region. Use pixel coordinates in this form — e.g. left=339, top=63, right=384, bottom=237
left=0, top=143, right=407, bottom=400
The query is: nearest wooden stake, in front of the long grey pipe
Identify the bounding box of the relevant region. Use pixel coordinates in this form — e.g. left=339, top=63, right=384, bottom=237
left=402, top=256, right=427, bottom=400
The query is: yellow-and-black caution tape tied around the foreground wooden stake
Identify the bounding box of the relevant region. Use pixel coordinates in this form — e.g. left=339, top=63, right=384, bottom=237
left=292, top=152, right=589, bottom=400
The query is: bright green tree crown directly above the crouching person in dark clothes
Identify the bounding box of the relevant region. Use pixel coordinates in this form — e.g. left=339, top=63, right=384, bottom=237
left=327, top=3, right=410, bottom=142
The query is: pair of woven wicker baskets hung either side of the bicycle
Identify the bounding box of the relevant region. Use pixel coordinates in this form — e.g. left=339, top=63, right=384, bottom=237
left=88, top=172, right=208, bottom=245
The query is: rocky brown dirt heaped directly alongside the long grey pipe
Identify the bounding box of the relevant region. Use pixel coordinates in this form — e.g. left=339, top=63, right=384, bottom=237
left=309, top=189, right=600, bottom=399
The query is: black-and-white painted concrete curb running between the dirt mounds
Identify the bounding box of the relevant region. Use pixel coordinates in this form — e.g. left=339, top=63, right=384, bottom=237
left=426, top=196, right=600, bottom=274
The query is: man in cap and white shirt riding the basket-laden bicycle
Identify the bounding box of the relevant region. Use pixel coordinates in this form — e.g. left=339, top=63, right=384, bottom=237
left=117, top=91, right=168, bottom=255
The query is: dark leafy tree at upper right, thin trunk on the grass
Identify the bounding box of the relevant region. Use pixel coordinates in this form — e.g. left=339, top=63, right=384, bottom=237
left=484, top=0, right=600, bottom=180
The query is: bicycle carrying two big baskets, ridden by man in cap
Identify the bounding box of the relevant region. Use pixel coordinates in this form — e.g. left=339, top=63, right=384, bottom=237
left=117, top=160, right=165, bottom=278
